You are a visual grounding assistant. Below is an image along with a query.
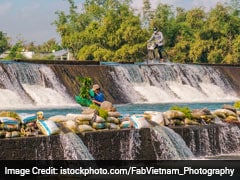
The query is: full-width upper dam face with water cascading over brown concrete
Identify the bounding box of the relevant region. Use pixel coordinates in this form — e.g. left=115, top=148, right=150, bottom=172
left=0, top=62, right=240, bottom=108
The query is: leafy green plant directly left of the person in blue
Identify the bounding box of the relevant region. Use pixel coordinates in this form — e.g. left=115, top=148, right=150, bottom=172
left=76, top=77, right=92, bottom=99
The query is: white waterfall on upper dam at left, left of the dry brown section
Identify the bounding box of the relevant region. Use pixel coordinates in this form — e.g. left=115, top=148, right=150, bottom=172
left=0, top=63, right=76, bottom=109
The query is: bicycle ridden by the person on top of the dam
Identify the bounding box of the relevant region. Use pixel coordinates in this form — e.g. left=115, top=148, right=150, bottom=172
left=147, top=42, right=170, bottom=64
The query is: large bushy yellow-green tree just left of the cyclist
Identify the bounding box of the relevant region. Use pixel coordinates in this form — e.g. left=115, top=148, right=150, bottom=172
left=55, top=0, right=148, bottom=61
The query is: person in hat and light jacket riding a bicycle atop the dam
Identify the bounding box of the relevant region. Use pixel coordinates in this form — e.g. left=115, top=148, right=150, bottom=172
left=148, top=27, right=164, bottom=62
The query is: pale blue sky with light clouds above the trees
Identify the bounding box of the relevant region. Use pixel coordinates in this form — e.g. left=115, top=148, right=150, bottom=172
left=0, top=0, right=226, bottom=44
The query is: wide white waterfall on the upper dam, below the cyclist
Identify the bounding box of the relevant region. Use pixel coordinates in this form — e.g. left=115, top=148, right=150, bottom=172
left=111, top=64, right=239, bottom=103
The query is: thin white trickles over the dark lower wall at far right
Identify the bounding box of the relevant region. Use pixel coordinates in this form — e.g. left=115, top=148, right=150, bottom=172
left=183, top=123, right=240, bottom=156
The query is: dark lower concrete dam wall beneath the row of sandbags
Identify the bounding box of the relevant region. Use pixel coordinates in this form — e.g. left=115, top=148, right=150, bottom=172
left=0, top=125, right=240, bottom=160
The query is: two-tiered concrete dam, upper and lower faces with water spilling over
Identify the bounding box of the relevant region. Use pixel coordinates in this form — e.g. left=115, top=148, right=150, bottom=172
left=0, top=61, right=240, bottom=160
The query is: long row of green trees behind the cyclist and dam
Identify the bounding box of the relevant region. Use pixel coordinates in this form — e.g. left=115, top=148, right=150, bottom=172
left=0, top=0, right=240, bottom=64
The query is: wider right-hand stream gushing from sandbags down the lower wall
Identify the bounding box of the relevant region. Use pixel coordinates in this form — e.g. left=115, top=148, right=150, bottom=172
left=151, top=126, right=193, bottom=160
